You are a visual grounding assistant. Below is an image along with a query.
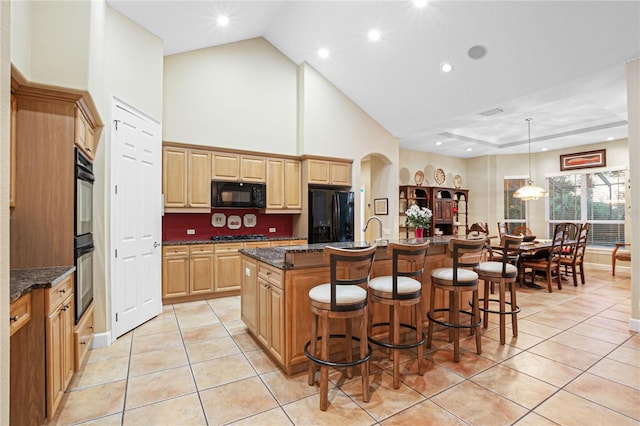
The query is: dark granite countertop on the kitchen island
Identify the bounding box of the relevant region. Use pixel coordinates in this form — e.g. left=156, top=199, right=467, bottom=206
left=240, top=235, right=466, bottom=269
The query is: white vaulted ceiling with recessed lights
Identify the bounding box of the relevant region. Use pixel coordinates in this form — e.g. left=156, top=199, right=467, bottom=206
left=108, top=0, right=640, bottom=158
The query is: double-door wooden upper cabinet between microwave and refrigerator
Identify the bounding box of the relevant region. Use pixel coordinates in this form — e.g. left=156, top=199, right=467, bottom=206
left=267, top=158, right=302, bottom=213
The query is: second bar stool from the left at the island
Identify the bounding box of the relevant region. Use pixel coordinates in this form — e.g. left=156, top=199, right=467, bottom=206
left=368, top=242, right=429, bottom=389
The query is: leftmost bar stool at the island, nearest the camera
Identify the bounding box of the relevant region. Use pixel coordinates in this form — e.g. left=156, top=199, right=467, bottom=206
left=304, top=246, right=377, bottom=411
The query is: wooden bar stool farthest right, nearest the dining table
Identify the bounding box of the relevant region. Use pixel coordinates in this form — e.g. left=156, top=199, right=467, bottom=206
left=474, top=235, right=523, bottom=345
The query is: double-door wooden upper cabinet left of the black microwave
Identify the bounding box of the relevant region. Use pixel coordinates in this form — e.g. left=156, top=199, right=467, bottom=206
left=162, top=146, right=211, bottom=212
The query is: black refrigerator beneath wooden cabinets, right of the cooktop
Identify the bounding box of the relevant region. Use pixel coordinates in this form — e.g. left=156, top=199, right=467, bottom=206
left=308, top=189, right=354, bottom=244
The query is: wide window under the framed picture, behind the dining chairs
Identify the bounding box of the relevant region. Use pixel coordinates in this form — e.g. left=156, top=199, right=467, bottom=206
left=547, top=170, right=626, bottom=246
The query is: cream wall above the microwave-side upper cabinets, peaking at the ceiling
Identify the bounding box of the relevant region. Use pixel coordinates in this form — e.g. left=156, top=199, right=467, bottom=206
left=163, top=38, right=297, bottom=155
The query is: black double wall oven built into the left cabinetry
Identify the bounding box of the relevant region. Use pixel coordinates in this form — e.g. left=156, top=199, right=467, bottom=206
left=74, top=148, right=95, bottom=324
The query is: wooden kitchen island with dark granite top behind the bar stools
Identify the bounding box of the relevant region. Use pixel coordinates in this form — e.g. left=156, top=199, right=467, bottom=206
left=240, top=236, right=464, bottom=374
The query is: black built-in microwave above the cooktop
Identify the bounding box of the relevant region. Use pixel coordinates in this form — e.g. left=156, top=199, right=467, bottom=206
left=211, top=181, right=267, bottom=209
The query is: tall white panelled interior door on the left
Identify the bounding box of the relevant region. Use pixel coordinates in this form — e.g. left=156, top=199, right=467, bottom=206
left=110, top=98, right=162, bottom=340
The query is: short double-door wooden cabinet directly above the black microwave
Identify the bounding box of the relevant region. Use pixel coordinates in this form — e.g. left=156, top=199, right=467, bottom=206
left=211, top=152, right=267, bottom=183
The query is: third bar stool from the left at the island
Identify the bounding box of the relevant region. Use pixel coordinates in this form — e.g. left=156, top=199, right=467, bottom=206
left=427, top=238, right=485, bottom=362
